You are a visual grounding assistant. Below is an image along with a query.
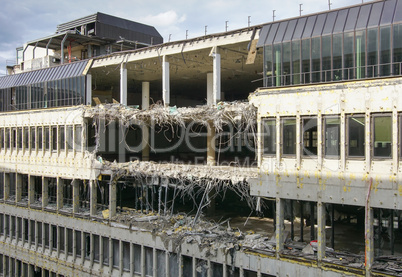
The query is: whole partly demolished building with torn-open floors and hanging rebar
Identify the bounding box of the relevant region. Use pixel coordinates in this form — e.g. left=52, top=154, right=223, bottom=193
left=0, top=0, right=402, bottom=277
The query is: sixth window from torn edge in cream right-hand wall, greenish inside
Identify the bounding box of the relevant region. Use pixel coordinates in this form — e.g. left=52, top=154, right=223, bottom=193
left=373, top=115, right=392, bottom=158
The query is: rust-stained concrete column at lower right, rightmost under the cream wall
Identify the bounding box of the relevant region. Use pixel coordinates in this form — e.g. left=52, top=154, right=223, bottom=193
left=364, top=206, right=381, bottom=277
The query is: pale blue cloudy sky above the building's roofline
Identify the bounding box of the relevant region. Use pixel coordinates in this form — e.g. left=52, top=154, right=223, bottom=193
left=0, top=0, right=367, bottom=76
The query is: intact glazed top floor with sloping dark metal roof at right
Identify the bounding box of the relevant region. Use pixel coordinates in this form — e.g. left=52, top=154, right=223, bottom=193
left=258, top=0, right=402, bottom=87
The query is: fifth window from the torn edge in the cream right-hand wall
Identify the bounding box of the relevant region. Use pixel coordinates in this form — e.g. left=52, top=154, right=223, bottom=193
left=347, top=115, right=366, bottom=157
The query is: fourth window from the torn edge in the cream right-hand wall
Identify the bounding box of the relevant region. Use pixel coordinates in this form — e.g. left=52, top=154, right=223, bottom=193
left=324, top=116, right=341, bottom=157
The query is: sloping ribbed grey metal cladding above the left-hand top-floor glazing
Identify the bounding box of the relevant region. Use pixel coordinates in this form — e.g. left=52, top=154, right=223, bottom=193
left=0, top=61, right=88, bottom=89
